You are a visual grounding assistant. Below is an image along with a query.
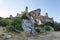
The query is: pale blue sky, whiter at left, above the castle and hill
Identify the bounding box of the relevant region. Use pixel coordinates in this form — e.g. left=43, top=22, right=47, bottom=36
left=0, top=0, right=60, bottom=22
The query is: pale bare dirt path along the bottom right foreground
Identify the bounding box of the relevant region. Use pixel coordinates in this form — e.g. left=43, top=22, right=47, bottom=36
left=28, top=32, right=60, bottom=40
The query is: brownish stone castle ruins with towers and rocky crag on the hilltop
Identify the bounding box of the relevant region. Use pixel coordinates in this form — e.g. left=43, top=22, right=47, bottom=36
left=10, top=6, right=53, bottom=25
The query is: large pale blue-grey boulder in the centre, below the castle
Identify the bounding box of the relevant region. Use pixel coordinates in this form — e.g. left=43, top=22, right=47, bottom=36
left=22, top=19, right=37, bottom=34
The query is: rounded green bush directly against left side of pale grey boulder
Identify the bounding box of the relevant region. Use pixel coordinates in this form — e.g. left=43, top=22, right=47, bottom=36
left=11, top=17, right=22, bottom=31
